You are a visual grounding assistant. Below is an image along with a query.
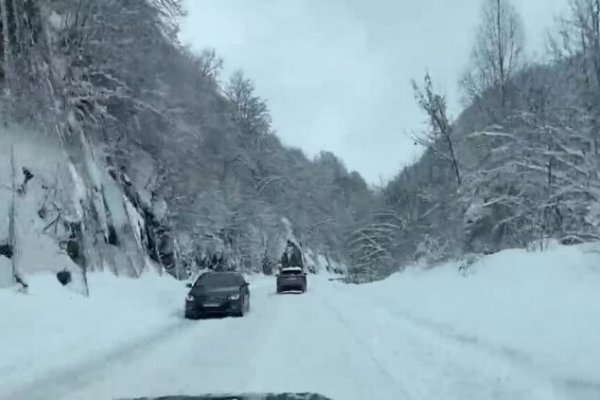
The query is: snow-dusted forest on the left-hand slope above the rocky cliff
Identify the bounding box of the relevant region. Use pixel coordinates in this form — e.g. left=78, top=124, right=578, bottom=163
left=0, top=0, right=374, bottom=288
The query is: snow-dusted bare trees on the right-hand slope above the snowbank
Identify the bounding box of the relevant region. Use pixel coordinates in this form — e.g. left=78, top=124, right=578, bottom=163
left=354, top=0, right=600, bottom=275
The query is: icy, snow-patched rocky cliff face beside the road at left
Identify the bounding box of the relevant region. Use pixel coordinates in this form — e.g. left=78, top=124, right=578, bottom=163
left=0, top=126, right=176, bottom=292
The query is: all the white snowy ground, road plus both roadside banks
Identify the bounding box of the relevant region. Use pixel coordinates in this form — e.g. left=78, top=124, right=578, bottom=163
left=0, top=245, right=600, bottom=400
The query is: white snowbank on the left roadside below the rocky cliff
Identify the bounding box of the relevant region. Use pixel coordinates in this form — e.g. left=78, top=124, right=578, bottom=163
left=0, top=273, right=187, bottom=397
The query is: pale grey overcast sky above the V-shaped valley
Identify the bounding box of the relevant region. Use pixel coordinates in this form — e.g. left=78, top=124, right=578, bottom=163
left=181, top=0, right=568, bottom=183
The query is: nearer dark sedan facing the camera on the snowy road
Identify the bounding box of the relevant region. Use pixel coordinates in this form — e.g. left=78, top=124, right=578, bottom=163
left=185, top=272, right=250, bottom=319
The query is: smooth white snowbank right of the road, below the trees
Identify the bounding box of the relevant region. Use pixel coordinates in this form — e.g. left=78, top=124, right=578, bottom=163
left=338, top=244, right=600, bottom=398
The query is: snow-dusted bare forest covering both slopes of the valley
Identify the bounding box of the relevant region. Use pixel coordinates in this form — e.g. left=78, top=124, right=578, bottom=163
left=0, top=0, right=600, bottom=288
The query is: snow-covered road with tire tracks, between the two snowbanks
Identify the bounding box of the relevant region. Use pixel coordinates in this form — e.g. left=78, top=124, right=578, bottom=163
left=0, top=277, right=565, bottom=400
